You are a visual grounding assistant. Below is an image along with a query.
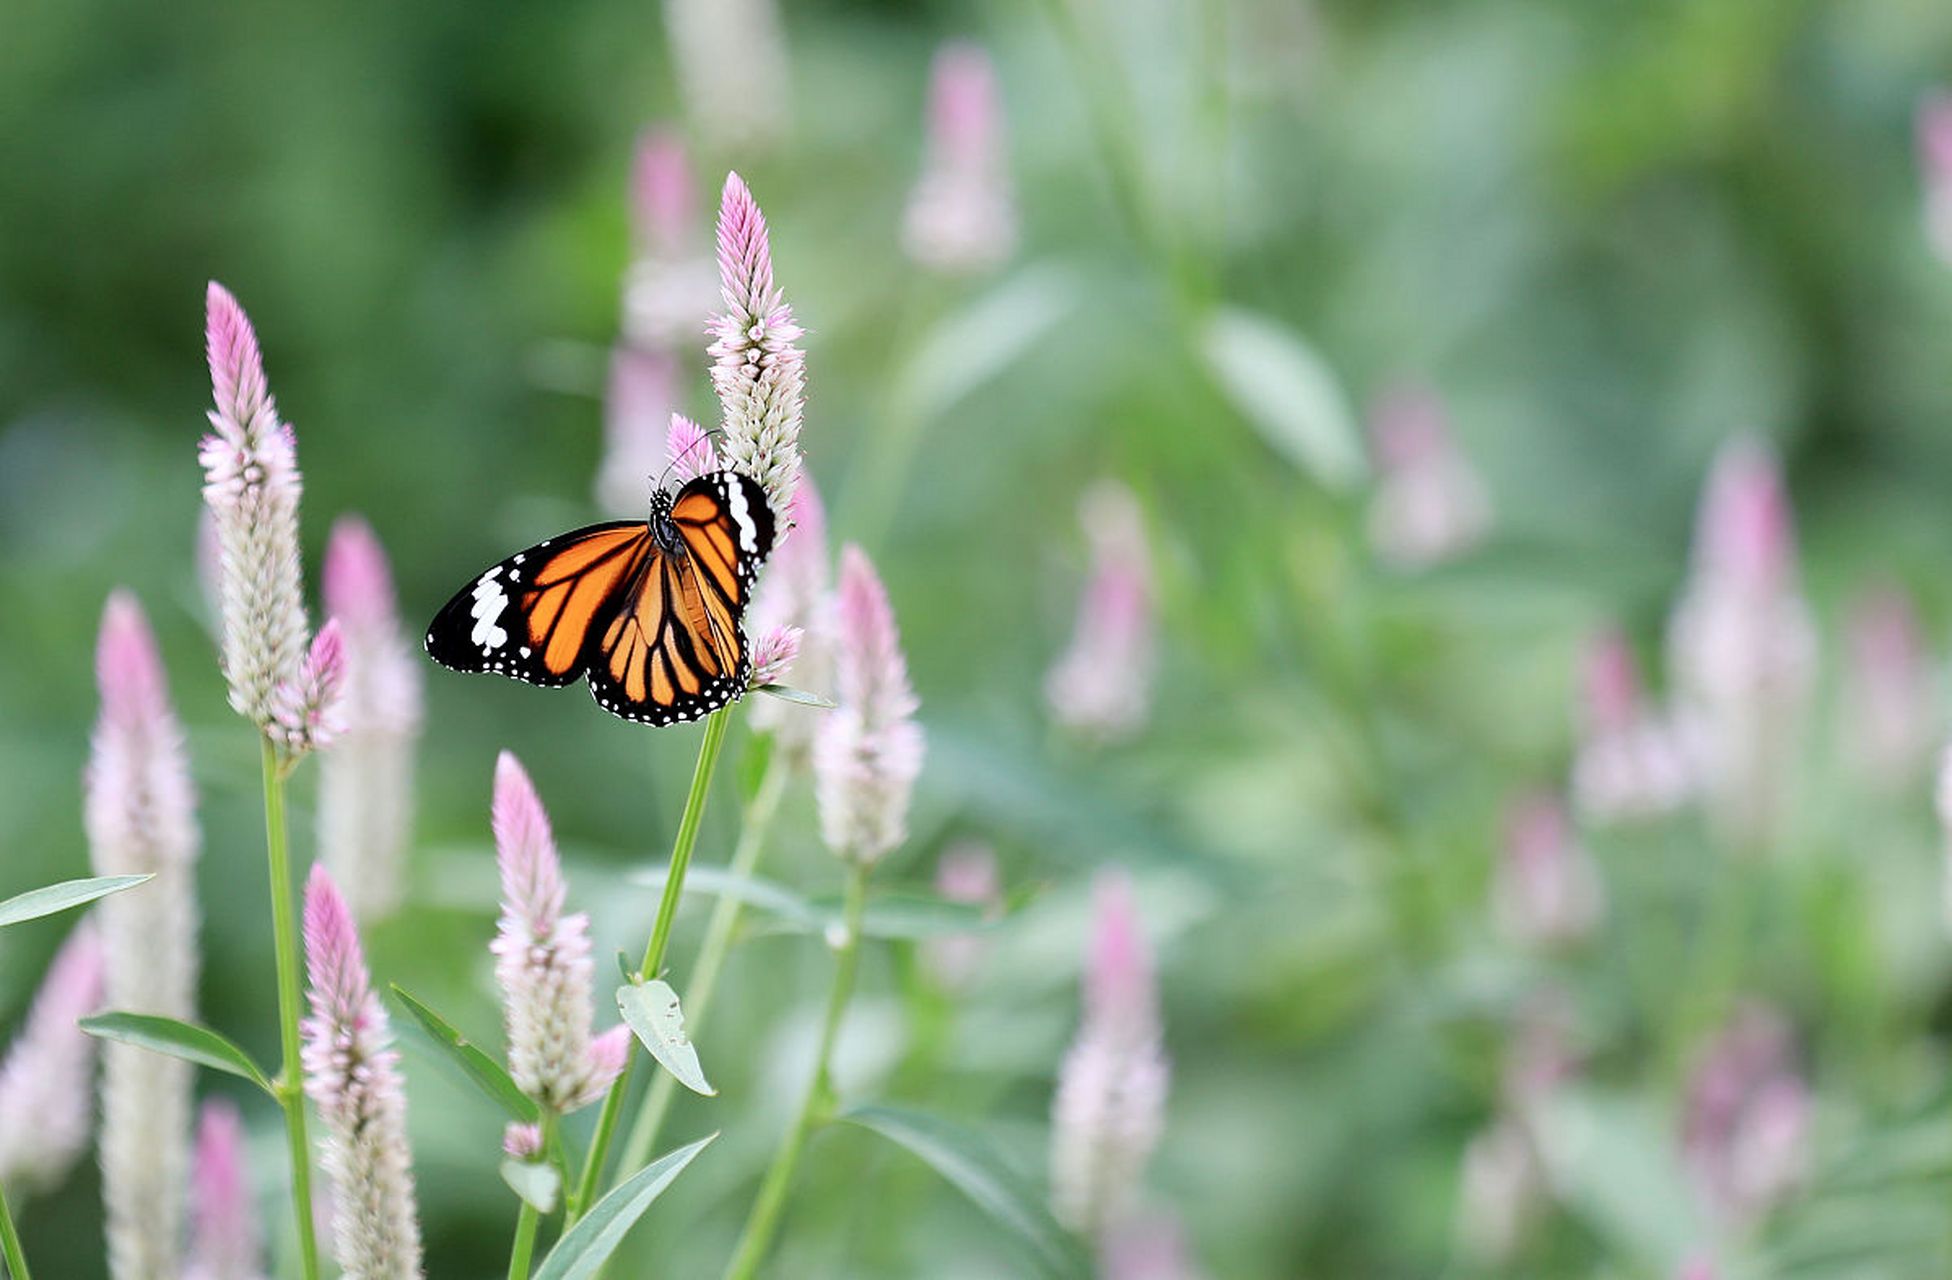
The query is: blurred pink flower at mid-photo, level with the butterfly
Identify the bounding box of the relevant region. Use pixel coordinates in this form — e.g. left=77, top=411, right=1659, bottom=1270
left=1044, top=480, right=1156, bottom=741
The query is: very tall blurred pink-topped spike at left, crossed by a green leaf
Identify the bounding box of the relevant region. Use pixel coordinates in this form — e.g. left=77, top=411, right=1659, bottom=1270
left=84, top=591, right=199, bottom=1276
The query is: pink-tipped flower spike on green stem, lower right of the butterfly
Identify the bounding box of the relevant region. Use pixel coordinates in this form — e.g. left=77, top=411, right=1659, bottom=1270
left=814, top=546, right=923, bottom=862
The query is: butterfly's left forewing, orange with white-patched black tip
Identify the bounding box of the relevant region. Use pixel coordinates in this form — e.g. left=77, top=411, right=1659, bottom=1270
left=427, top=521, right=656, bottom=687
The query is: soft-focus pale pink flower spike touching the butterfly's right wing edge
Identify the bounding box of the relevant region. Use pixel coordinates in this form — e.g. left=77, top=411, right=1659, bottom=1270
left=748, top=476, right=834, bottom=769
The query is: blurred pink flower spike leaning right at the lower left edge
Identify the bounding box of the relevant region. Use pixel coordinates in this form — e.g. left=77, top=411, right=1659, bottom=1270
left=0, top=923, right=103, bottom=1192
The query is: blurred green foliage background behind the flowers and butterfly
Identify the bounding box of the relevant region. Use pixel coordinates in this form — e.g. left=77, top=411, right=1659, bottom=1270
left=0, top=0, right=1952, bottom=1278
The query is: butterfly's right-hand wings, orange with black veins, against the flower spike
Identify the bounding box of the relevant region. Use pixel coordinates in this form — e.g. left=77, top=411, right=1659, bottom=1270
left=590, top=470, right=775, bottom=724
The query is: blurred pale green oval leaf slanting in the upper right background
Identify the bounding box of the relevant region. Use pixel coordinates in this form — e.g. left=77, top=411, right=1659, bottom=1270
left=1200, top=306, right=1368, bottom=490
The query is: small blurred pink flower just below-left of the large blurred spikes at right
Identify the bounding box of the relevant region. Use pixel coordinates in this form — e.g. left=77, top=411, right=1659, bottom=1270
left=1493, top=794, right=1605, bottom=946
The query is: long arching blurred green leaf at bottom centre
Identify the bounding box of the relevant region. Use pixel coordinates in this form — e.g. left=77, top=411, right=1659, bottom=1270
left=839, top=1106, right=1089, bottom=1276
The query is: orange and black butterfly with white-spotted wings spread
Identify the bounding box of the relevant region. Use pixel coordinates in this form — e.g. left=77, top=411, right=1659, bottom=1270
left=427, top=470, right=777, bottom=724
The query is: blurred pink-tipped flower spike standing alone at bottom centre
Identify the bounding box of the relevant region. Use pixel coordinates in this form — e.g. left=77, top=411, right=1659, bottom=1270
left=1050, top=872, right=1169, bottom=1241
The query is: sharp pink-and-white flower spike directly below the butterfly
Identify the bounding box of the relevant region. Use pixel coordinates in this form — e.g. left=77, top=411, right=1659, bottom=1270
left=490, top=751, right=629, bottom=1112
